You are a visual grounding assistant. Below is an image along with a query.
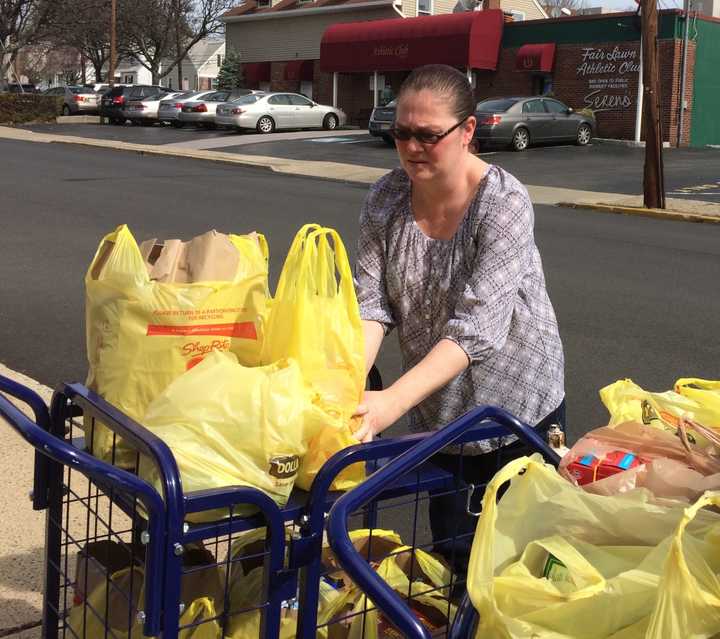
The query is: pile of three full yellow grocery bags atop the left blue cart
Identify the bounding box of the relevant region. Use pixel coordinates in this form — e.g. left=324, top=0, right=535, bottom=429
left=85, top=224, right=365, bottom=504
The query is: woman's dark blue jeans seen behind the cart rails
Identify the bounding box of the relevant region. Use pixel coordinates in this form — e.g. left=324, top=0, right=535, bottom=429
left=429, top=400, right=565, bottom=585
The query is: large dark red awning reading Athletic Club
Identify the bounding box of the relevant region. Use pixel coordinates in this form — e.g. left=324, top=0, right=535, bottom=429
left=320, top=9, right=504, bottom=72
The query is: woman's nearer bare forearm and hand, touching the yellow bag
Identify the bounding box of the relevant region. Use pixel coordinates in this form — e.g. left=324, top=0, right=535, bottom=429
left=355, top=338, right=470, bottom=442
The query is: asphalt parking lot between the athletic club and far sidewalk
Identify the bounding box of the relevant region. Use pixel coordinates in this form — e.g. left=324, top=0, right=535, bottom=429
left=19, top=124, right=720, bottom=203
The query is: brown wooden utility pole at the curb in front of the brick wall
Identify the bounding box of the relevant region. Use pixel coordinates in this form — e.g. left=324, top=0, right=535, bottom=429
left=641, top=0, right=665, bottom=209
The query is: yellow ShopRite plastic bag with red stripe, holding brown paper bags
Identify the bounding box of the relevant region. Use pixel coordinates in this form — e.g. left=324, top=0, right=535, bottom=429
left=85, top=226, right=268, bottom=466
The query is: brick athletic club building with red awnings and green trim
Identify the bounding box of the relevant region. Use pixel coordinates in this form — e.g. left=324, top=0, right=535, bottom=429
left=225, top=0, right=720, bottom=146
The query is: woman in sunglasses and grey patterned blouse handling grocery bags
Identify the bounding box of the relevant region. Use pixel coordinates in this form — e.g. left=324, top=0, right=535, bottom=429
left=356, top=65, right=565, bottom=573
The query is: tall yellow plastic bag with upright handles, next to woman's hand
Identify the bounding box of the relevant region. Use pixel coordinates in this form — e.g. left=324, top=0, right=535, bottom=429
left=262, top=224, right=365, bottom=490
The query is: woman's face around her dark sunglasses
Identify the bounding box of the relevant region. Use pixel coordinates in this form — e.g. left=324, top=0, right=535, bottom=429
left=395, top=89, right=475, bottom=182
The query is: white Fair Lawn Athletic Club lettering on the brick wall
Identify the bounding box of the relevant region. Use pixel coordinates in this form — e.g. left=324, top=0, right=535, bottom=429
left=576, top=45, right=640, bottom=113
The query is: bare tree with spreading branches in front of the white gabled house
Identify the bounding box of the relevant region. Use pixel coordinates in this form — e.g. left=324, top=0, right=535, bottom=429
left=125, top=0, right=237, bottom=84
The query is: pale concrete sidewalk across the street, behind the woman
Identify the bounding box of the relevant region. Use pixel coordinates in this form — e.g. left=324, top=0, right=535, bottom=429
left=0, top=126, right=720, bottom=222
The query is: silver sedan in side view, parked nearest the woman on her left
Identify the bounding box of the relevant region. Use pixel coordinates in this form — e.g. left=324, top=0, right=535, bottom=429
left=216, top=93, right=347, bottom=133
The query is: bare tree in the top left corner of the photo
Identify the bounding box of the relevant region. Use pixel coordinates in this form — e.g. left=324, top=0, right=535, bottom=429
left=0, top=0, right=52, bottom=82
